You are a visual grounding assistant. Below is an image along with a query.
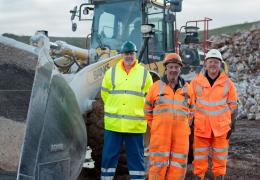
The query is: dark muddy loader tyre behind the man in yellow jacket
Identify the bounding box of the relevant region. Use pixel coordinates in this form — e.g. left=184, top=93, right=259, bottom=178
left=81, top=93, right=128, bottom=178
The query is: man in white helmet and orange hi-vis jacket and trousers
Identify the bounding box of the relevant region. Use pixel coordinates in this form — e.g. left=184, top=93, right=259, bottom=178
left=191, top=49, right=237, bottom=180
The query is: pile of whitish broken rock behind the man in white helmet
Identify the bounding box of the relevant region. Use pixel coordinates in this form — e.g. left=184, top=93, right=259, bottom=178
left=210, top=24, right=260, bottom=120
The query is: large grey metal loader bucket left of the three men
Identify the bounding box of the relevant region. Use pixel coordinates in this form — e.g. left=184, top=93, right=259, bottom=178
left=17, top=43, right=87, bottom=180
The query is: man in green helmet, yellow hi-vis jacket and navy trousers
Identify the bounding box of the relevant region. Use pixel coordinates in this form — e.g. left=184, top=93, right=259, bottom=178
left=101, top=41, right=152, bottom=179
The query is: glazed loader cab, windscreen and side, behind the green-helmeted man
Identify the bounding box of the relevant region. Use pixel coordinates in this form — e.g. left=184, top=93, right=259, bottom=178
left=88, top=0, right=174, bottom=74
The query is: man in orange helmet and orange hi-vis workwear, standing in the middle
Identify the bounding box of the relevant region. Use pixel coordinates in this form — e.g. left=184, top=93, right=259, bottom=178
left=144, top=53, right=194, bottom=180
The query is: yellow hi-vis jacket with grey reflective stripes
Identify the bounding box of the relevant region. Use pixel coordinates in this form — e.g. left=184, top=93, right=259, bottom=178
left=101, top=60, right=152, bottom=133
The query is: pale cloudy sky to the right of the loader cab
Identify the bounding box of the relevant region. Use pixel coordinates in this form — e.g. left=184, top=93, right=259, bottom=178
left=177, top=0, right=260, bottom=28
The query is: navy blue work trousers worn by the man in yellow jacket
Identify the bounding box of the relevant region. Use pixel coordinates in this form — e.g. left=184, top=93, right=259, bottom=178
left=101, top=130, right=145, bottom=180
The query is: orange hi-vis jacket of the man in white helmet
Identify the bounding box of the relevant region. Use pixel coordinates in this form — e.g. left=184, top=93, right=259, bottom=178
left=191, top=71, right=237, bottom=138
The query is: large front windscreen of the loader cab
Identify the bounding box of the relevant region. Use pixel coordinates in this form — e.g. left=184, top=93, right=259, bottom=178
left=91, top=0, right=142, bottom=52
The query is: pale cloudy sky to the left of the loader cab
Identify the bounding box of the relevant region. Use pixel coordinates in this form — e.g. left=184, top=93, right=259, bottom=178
left=0, top=0, right=87, bottom=36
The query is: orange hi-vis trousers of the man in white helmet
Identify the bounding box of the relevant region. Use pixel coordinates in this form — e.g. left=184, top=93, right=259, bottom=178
left=193, top=134, right=229, bottom=179
